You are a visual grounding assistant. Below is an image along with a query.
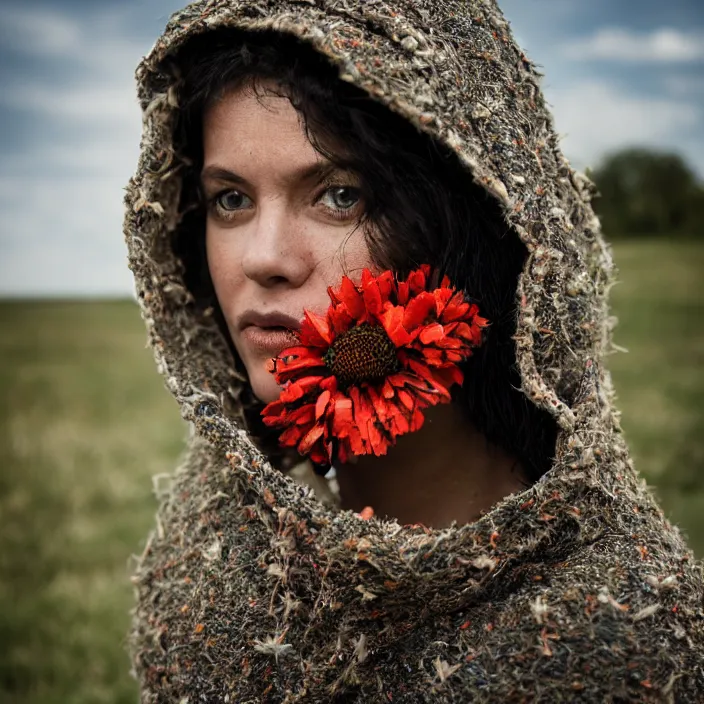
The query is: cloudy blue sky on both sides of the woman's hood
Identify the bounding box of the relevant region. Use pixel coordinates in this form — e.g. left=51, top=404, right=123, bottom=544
left=0, top=0, right=704, bottom=295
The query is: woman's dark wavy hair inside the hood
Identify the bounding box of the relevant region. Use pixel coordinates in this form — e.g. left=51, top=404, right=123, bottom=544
left=173, top=29, right=556, bottom=481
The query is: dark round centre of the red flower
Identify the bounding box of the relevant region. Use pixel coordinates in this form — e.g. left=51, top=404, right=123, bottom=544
left=324, top=323, right=398, bottom=388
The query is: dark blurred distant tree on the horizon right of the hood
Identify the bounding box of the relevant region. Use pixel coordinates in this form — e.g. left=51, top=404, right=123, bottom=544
left=590, top=149, right=704, bottom=238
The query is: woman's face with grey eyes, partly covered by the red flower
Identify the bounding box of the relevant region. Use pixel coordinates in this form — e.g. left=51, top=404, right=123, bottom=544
left=201, top=84, right=373, bottom=403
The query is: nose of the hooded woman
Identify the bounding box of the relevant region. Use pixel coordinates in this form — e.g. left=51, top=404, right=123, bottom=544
left=242, top=202, right=310, bottom=287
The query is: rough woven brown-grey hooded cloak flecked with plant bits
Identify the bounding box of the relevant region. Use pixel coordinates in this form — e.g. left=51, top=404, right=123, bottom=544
left=125, top=0, right=704, bottom=704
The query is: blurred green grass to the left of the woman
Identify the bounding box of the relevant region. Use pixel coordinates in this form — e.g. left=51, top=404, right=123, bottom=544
left=0, top=302, right=184, bottom=704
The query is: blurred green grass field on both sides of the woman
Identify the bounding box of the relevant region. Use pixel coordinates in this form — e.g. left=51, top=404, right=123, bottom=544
left=0, top=242, right=704, bottom=704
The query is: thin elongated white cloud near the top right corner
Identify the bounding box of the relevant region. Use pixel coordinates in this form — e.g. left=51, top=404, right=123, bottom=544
left=563, top=27, right=704, bottom=63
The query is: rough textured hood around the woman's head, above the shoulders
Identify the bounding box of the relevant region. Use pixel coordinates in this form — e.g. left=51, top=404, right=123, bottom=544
left=125, top=1, right=613, bottom=468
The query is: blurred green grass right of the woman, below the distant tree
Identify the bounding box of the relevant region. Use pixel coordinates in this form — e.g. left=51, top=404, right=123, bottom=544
left=609, top=241, right=704, bottom=557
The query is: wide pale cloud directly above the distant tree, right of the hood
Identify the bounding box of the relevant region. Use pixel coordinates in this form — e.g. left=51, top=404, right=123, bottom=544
left=548, top=81, right=704, bottom=174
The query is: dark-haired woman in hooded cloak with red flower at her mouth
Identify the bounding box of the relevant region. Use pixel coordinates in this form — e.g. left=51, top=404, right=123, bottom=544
left=125, top=0, right=704, bottom=702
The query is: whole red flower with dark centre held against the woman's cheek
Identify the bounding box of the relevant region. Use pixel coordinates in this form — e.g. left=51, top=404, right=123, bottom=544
left=262, top=265, right=487, bottom=465
